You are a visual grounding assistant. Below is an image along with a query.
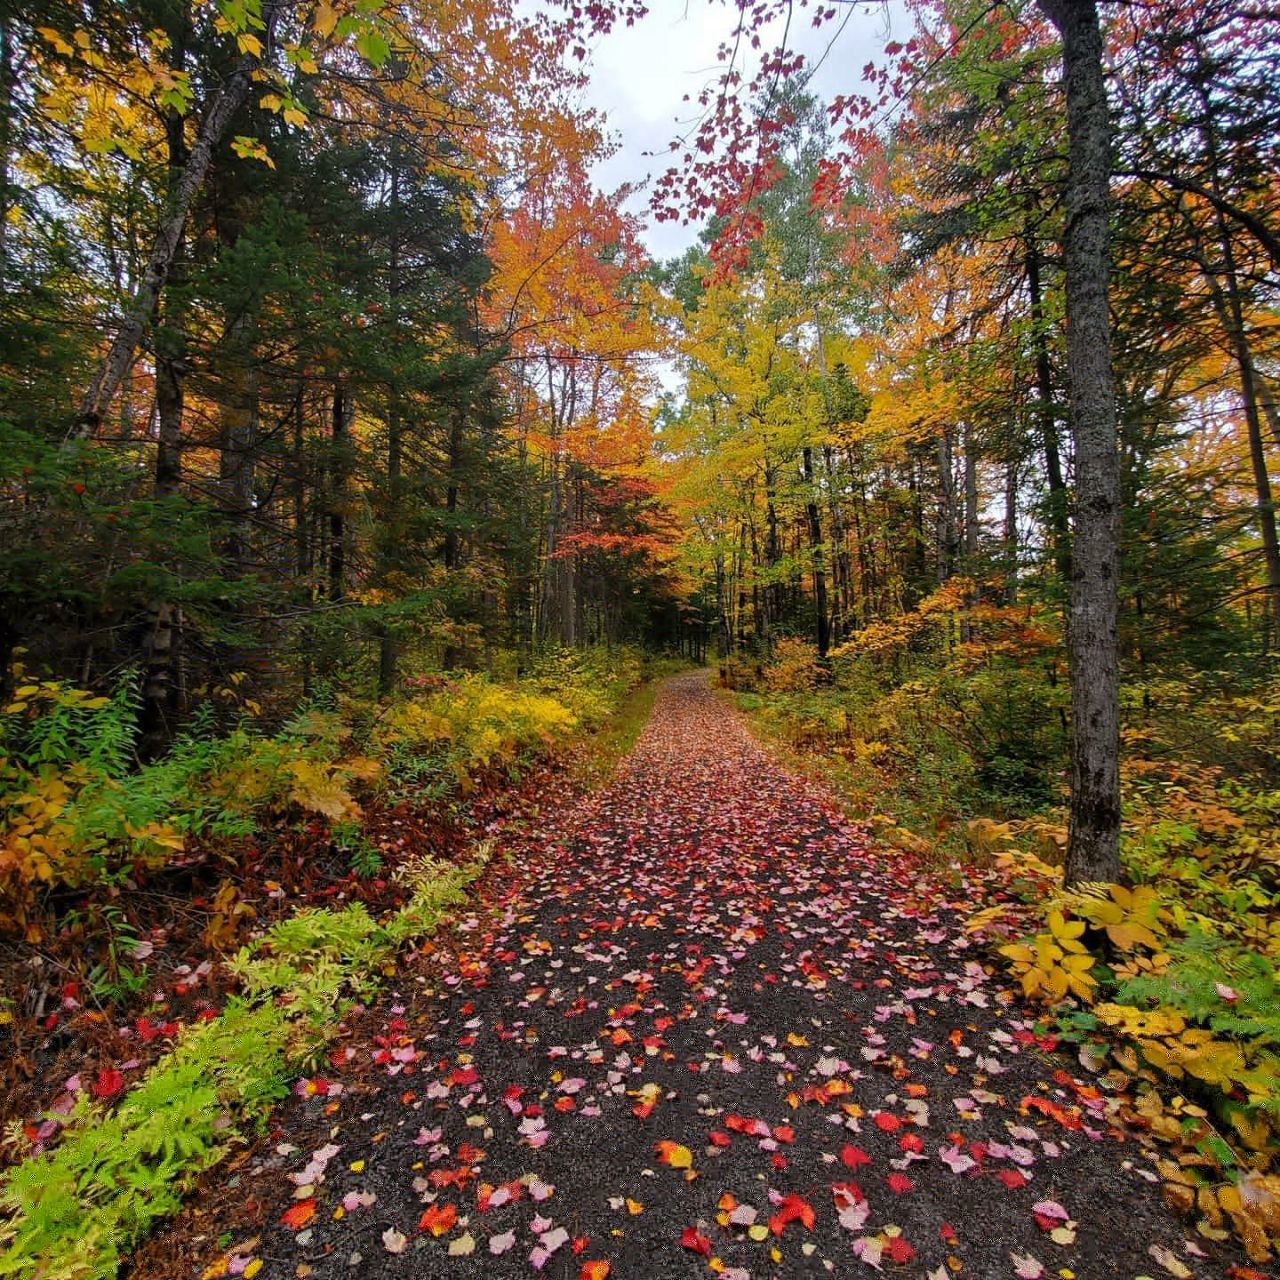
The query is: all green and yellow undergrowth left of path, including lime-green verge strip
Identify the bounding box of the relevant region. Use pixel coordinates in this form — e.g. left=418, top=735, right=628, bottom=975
left=0, top=650, right=657, bottom=1280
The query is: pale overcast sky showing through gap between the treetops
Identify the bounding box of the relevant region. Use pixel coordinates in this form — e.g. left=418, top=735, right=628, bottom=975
left=576, top=0, right=908, bottom=259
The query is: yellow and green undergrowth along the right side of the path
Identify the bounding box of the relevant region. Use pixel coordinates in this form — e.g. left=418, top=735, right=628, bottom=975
left=722, top=580, right=1280, bottom=1261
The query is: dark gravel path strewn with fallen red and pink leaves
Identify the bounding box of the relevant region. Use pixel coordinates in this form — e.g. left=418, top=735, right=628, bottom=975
left=142, top=673, right=1256, bottom=1280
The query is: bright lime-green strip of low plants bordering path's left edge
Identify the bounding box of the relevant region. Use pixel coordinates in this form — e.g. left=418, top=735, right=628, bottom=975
left=0, top=847, right=488, bottom=1280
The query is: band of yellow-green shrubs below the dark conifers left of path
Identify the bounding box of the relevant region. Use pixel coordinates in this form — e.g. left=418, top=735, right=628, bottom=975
left=0, top=649, right=643, bottom=936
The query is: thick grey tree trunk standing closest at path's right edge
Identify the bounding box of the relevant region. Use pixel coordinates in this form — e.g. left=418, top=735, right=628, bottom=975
left=1038, top=0, right=1120, bottom=884
